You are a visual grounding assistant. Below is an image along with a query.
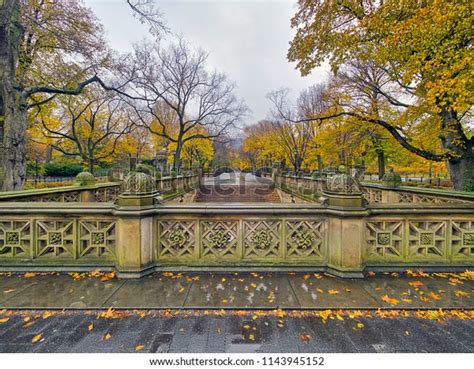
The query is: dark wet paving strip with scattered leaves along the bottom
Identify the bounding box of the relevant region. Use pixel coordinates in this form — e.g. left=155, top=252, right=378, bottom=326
left=0, top=311, right=474, bottom=353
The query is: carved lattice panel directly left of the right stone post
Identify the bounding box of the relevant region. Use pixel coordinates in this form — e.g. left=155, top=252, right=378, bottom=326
left=285, top=220, right=324, bottom=257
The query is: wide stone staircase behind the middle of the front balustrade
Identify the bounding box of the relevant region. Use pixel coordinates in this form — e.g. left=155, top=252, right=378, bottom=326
left=195, top=185, right=281, bottom=203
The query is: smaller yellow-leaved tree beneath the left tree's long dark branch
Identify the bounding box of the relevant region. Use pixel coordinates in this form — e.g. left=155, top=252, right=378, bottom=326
left=36, top=88, right=133, bottom=173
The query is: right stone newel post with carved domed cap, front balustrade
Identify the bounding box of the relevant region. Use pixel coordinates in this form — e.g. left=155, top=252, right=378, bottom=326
left=322, top=166, right=367, bottom=277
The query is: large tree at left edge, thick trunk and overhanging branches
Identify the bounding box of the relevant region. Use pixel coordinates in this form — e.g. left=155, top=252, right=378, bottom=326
left=0, top=0, right=164, bottom=190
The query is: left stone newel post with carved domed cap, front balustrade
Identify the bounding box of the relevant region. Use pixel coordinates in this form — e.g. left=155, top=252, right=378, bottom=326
left=116, top=172, right=161, bottom=278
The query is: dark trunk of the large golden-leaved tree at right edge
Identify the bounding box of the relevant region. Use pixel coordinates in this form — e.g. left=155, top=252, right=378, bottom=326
left=440, top=110, right=474, bottom=191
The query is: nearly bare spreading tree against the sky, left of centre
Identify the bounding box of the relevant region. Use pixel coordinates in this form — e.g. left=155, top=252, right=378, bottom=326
left=128, top=39, right=247, bottom=171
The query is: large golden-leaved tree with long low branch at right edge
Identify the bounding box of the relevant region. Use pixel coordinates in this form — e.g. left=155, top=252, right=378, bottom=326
left=288, top=0, right=474, bottom=190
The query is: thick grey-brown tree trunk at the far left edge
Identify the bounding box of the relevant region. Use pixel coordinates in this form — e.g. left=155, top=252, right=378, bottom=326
left=0, top=0, right=27, bottom=191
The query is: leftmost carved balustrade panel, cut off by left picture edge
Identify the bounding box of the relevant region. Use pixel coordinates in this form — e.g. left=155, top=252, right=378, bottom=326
left=0, top=220, right=31, bottom=257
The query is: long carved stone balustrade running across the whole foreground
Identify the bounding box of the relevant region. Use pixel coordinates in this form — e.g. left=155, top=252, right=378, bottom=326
left=0, top=195, right=474, bottom=277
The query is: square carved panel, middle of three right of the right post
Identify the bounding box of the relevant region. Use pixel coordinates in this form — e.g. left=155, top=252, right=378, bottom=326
left=408, top=221, right=446, bottom=258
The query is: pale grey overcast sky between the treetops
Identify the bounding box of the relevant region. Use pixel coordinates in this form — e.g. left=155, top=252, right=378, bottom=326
left=84, top=0, right=328, bottom=124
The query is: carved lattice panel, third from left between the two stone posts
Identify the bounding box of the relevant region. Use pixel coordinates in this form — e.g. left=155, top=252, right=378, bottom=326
left=244, top=220, right=281, bottom=258
